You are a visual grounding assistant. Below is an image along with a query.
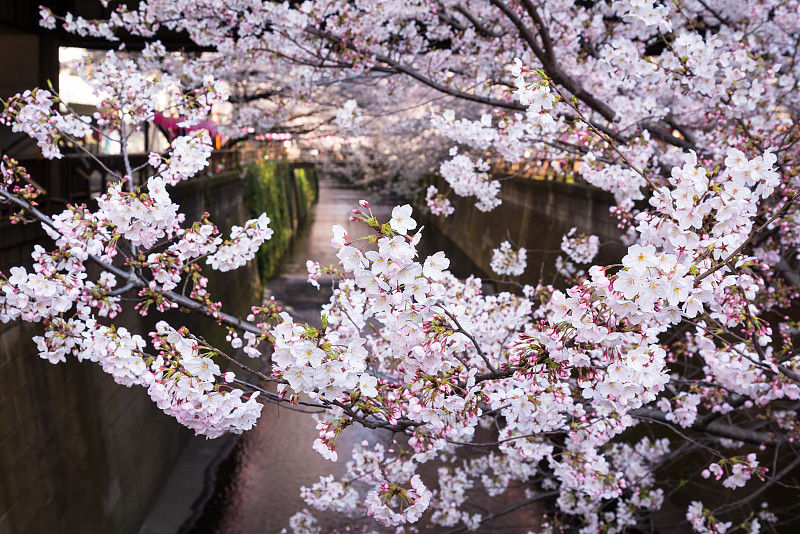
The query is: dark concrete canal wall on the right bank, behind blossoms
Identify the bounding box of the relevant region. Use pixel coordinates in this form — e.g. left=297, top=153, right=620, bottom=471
left=429, top=178, right=624, bottom=284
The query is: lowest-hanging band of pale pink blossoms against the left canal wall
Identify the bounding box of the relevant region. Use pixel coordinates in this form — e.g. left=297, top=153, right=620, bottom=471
left=0, top=251, right=261, bottom=437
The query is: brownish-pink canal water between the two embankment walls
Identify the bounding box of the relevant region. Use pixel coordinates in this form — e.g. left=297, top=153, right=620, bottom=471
left=145, top=178, right=532, bottom=534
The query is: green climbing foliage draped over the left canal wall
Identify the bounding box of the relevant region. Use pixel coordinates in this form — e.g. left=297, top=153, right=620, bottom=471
left=244, top=160, right=318, bottom=282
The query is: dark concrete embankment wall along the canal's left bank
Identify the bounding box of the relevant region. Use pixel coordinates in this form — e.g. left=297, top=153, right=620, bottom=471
left=0, top=164, right=318, bottom=534
